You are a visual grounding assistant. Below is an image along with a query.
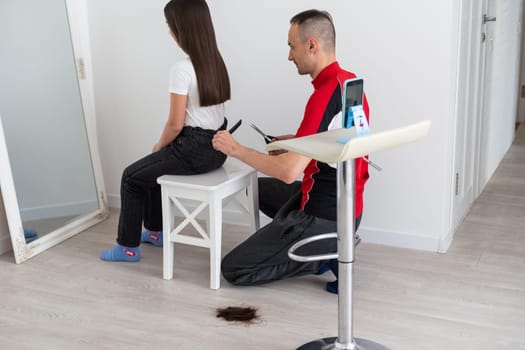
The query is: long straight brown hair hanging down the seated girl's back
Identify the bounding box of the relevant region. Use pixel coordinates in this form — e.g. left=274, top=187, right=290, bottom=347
left=164, top=0, right=231, bottom=106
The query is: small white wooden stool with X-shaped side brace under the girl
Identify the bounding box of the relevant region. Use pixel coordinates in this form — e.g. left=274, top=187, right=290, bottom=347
left=157, top=159, right=259, bottom=289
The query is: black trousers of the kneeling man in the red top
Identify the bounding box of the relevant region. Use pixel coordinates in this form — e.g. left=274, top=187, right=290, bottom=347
left=221, top=178, right=360, bottom=285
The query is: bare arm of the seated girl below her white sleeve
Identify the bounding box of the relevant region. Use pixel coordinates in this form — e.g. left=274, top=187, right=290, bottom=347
left=153, top=93, right=188, bottom=152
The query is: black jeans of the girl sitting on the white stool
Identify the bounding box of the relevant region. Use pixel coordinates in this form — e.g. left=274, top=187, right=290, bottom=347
left=117, top=121, right=226, bottom=247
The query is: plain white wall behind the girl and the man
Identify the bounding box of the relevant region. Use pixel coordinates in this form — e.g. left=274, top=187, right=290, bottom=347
left=88, top=0, right=458, bottom=251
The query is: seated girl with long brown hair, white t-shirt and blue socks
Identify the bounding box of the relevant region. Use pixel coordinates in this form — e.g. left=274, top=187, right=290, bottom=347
left=100, top=0, right=230, bottom=261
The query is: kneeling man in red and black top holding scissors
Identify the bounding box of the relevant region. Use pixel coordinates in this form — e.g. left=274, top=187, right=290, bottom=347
left=212, top=10, right=368, bottom=292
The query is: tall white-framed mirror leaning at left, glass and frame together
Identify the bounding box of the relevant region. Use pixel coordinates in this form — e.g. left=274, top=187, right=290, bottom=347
left=0, top=0, right=108, bottom=263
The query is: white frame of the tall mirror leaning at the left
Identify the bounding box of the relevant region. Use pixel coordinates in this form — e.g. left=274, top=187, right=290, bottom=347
left=0, top=0, right=109, bottom=264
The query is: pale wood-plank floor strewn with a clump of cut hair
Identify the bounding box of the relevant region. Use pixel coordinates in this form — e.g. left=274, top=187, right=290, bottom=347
left=0, top=127, right=525, bottom=350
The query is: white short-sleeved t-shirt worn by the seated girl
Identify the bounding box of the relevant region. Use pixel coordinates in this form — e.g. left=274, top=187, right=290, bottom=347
left=169, top=57, right=224, bottom=130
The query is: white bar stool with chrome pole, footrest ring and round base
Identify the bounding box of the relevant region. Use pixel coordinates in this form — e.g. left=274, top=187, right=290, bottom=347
left=266, top=120, right=431, bottom=350
